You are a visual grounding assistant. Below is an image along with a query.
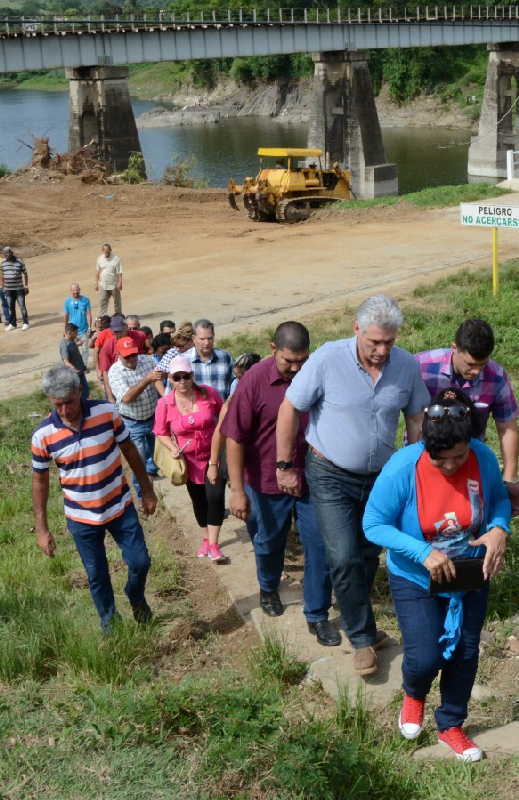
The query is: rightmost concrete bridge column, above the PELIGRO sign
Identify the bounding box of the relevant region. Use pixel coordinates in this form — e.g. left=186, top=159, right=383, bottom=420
left=468, top=42, right=519, bottom=178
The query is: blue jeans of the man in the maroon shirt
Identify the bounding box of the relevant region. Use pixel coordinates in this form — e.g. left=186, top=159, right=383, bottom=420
left=247, top=486, right=332, bottom=622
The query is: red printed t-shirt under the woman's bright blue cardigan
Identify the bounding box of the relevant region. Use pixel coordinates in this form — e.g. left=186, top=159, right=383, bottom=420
left=416, top=450, right=483, bottom=556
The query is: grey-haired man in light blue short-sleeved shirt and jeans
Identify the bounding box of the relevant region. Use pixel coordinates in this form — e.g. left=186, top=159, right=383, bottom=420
left=277, top=295, right=429, bottom=675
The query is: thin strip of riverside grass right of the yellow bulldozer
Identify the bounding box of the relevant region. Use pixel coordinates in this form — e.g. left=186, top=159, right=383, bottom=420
left=333, top=183, right=508, bottom=211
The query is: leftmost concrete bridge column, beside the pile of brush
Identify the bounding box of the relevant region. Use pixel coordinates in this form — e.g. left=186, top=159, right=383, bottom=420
left=65, top=67, right=141, bottom=172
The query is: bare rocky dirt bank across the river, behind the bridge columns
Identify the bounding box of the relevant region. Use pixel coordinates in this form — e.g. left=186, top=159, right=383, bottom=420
left=137, top=78, right=473, bottom=128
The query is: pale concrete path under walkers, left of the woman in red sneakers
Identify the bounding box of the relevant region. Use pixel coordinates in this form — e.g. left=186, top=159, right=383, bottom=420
left=154, top=479, right=402, bottom=705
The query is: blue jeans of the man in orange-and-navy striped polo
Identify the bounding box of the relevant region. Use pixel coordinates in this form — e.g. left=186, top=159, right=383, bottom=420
left=67, top=504, right=151, bottom=629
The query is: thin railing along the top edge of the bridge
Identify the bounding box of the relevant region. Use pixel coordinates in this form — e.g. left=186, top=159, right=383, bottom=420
left=0, top=5, right=519, bottom=37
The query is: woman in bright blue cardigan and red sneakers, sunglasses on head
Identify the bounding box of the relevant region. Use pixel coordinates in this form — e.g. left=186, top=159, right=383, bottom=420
left=363, top=388, right=510, bottom=761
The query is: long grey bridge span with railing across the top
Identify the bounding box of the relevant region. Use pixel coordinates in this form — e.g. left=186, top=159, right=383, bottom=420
left=0, top=6, right=519, bottom=73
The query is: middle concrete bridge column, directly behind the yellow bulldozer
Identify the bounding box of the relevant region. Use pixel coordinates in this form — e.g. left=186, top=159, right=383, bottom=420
left=308, top=51, right=398, bottom=198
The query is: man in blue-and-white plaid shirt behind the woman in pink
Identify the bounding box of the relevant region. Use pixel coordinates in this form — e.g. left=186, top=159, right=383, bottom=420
left=156, top=319, right=234, bottom=400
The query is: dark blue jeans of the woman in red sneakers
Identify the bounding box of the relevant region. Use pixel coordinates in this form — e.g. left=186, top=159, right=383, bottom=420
left=389, top=573, right=488, bottom=731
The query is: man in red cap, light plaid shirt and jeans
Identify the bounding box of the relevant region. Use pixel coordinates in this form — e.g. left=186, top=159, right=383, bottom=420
left=108, top=336, right=164, bottom=500
